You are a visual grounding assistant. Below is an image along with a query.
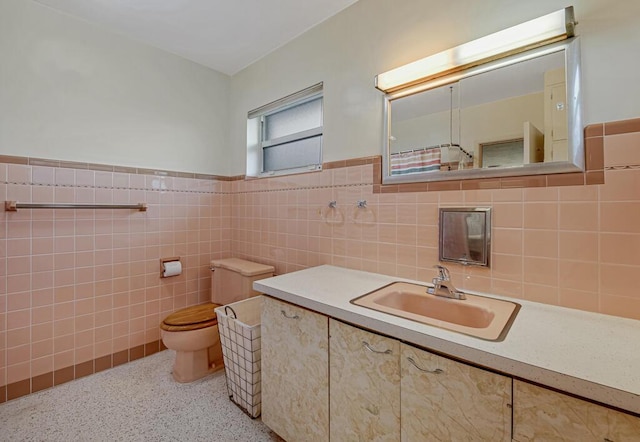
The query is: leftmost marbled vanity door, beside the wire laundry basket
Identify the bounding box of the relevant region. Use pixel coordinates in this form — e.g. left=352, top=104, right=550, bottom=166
left=261, top=297, right=329, bottom=442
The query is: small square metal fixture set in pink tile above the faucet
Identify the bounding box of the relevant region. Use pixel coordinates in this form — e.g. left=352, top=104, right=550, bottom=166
left=439, top=207, right=491, bottom=267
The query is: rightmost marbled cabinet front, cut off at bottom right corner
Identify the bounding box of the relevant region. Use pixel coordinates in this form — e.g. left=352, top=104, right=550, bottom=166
left=513, top=381, right=640, bottom=442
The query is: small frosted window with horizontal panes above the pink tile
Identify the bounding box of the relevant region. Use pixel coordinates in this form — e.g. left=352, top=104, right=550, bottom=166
left=247, top=83, right=323, bottom=176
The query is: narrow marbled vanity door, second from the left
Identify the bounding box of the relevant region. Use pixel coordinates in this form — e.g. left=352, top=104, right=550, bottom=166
left=329, top=319, right=400, bottom=442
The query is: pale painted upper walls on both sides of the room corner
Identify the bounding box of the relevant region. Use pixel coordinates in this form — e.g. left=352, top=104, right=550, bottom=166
left=0, top=0, right=640, bottom=175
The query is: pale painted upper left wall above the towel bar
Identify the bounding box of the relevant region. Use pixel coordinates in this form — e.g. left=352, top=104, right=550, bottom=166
left=0, top=0, right=230, bottom=175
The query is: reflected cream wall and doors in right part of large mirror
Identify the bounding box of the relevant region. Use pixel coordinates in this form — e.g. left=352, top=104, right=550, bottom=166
left=460, top=51, right=569, bottom=168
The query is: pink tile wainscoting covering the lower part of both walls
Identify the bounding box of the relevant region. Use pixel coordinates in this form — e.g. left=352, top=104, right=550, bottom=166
left=0, top=119, right=640, bottom=402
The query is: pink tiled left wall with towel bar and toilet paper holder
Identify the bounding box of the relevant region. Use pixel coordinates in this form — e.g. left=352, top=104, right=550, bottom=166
left=0, top=164, right=231, bottom=386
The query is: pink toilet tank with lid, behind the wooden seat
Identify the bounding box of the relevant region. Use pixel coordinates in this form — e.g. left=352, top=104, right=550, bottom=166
left=211, top=258, right=275, bottom=305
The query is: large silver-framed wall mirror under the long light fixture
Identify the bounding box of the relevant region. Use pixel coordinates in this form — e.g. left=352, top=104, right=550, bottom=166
left=382, top=38, right=584, bottom=184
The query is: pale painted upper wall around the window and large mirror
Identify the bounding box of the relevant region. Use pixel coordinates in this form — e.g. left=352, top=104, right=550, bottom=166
left=229, top=0, right=640, bottom=175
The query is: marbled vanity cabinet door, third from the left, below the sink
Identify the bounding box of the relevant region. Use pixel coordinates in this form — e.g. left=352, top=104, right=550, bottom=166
left=400, top=344, right=511, bottom=442
